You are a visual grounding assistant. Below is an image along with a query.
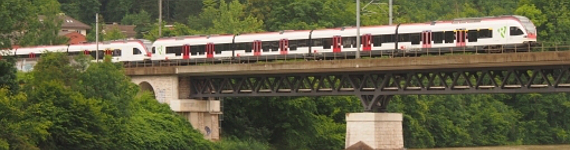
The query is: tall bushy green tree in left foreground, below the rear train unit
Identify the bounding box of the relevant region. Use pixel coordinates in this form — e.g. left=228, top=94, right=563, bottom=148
left=25, top=52, right=111, bottom=149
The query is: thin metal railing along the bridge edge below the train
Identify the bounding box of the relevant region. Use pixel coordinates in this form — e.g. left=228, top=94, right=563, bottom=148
left=118, top=41, right=570, bottom=68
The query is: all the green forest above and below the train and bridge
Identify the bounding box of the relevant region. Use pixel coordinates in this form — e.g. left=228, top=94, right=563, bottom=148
left=0, top=0, right=570, bottom=150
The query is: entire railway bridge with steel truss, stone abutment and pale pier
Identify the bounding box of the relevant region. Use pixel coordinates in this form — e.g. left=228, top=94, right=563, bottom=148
left=126, top=51, right=570, bottom=149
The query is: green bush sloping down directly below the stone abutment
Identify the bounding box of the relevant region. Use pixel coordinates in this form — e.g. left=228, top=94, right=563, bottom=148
left=118, top=93, right=213, bottom=150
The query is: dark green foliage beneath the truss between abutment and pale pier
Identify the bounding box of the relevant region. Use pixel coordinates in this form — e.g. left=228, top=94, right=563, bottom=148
left=223, top=97, right=361, bottom=149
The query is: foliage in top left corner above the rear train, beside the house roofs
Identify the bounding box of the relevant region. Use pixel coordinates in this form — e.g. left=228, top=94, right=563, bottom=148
left=0, top=0, right=67, bottom=49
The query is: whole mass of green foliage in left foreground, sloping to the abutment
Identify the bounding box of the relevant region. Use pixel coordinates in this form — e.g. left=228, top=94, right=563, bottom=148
left=0, top=52, right=213, bottom=150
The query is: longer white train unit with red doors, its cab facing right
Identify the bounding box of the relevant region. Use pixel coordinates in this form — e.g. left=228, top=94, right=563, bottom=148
left=151, top=15, right=537, bottom=60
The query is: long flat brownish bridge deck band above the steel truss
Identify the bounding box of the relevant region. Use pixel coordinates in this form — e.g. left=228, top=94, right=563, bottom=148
left=126, top=51, right=570, bottom=76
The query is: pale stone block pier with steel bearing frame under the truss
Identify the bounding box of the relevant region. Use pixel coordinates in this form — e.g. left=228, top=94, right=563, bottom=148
left=345, top=95, right=404, bottom=150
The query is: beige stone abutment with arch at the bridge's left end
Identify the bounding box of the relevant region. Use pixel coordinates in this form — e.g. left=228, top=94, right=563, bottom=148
left=131, top=75, right=222, bottom=141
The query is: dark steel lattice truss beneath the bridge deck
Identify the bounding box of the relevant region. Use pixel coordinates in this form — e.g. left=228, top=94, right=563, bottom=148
left=190, top=65, right=570, bottom=112
